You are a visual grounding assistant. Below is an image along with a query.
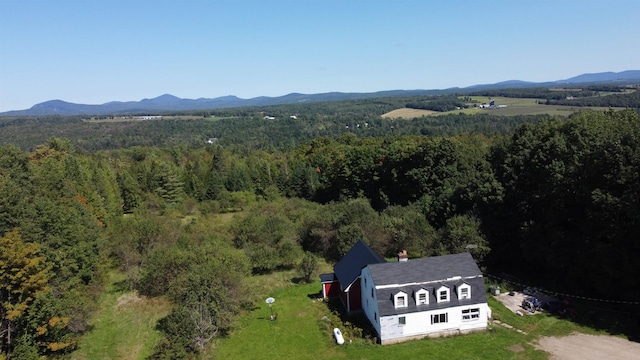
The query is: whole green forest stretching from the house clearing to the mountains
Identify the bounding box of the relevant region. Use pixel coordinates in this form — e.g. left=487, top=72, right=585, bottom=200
left=0, top=90, right=640, bottom=359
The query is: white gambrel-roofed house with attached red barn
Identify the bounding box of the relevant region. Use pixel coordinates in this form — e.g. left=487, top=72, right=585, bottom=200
left=321, top=242, right=489, bottom=345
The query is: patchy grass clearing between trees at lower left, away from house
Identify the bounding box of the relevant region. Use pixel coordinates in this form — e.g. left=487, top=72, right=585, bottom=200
left=69, top=272, right=170, bottom=360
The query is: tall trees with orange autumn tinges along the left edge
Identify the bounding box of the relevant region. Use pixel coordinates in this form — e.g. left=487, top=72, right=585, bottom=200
left=0, top=138, right=121, bottom=358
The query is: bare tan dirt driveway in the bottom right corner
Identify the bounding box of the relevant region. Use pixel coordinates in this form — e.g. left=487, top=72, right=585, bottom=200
left=536, top=333, right=640, bottom=360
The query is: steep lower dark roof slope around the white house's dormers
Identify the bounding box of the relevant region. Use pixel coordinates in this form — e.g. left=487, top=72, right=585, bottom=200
left=376, top=276, right=487, bottom=316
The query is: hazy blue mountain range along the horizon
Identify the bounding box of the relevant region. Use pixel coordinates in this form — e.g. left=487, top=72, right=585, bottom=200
left=0, top=70, right=640, bottom=116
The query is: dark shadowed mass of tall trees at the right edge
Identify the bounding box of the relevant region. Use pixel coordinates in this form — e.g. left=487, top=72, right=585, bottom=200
left=483, top=111, right=640, bottom=301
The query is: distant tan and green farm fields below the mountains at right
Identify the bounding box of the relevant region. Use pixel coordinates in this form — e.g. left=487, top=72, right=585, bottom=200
left=382, top=96, right=624, bottom=119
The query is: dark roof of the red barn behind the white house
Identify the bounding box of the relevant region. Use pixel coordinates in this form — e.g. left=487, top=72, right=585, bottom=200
left=333, top=240, right=386, bottom=291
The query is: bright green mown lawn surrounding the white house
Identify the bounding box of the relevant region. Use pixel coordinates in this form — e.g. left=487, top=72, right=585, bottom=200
left=214, top=274, right=595, bottom=359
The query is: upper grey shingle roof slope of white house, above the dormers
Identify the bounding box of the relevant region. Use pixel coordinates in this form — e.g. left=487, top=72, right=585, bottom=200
left=369, top=252, right=482, bottom=286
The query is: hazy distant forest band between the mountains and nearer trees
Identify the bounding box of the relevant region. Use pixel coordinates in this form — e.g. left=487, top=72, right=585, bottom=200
left=0, top=97, right=545, bottom=152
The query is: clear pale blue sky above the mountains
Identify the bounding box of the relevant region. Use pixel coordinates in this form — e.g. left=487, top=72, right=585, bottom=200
left=0, top=0, right=640, bottom=111
